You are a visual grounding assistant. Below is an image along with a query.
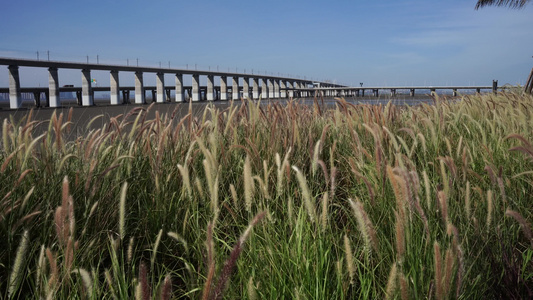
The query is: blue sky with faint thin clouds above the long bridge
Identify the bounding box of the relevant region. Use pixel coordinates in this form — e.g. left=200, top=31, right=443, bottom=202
left=0, top=0, right=533, bottom=87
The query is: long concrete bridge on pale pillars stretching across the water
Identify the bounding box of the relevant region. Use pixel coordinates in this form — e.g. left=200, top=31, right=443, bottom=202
left=0, top=57, right=498, bottom=109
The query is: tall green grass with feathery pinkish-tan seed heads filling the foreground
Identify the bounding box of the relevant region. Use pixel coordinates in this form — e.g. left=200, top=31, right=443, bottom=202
left=0, top=93, right=533, bottom=299
